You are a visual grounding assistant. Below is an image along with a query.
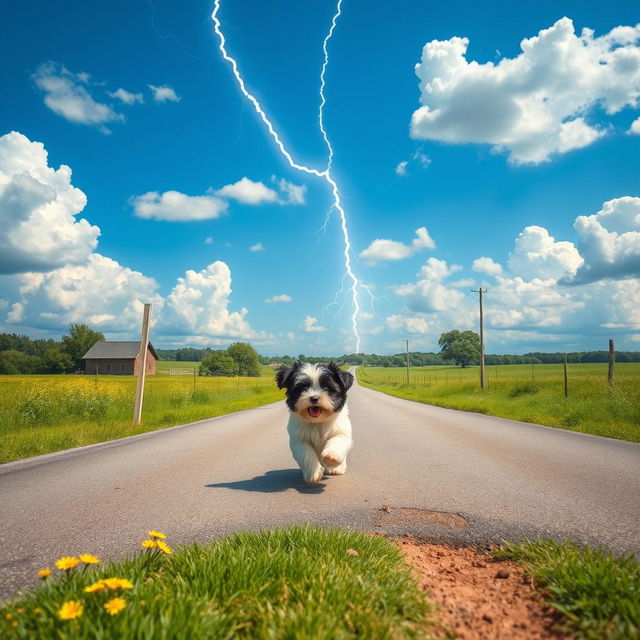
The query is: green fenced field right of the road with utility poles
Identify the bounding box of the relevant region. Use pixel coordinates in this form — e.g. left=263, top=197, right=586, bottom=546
left=358, top=363, right=640, bottom=442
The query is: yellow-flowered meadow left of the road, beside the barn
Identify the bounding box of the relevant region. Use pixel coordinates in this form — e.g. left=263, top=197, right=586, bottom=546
left=0, top=362, right=282, bottom=463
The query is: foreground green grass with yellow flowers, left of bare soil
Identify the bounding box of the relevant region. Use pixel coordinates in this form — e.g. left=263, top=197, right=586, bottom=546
left=0, top=526, right=431, bottom=640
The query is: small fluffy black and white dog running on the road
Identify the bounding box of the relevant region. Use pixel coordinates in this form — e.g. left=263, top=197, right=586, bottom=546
left=276, top=362, right=353, bottom=484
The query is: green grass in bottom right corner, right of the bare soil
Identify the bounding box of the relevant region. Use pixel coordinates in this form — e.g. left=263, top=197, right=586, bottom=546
left=496, top=540, right=640, bottom=640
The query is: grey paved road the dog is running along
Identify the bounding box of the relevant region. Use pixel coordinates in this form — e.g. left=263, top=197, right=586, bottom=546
left=0, top=376, right=640, bottom=596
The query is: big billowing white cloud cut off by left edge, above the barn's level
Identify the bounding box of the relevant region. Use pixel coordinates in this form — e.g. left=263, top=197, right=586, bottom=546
left=0, top=131, right=100, bottom=273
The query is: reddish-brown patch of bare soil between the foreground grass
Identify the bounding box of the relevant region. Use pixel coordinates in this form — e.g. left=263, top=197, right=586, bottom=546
left=397, top=538, right=571, bottom=640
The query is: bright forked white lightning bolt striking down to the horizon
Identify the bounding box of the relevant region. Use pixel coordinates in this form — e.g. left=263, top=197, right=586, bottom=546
left=211, top=0, right=360, bottom=353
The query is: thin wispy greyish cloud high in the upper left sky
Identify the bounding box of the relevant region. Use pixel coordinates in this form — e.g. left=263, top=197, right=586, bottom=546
left=32, top=61, right=124, bottom=133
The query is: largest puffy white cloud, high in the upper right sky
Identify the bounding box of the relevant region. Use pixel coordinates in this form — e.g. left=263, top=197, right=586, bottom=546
left=411, top=17, right=640, bottom=164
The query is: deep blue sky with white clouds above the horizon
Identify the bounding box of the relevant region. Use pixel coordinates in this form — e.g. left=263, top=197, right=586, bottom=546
left=0, top=0, right=640, bottom=354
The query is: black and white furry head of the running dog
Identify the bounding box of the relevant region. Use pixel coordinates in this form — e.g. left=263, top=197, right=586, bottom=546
left=276, top=362, right=353, bottom=422
